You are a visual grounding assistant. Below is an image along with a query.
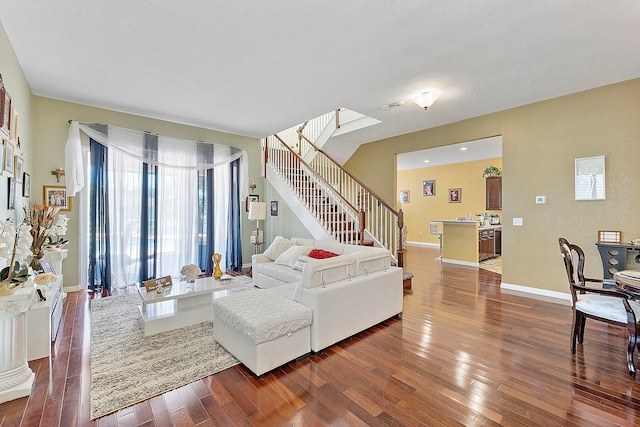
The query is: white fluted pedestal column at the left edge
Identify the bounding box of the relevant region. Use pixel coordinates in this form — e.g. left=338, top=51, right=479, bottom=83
left=0, top=289, right=35, bottom=403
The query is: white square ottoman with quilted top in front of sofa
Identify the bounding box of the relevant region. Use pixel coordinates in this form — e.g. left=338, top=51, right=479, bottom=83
left=213, top=290, right=313, bottom=375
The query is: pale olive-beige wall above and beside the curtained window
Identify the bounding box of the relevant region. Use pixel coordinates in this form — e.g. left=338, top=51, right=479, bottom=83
left=32, top=97, right=264, bottom=286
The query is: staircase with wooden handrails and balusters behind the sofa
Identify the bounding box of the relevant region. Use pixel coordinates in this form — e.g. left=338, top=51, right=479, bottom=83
left=262, top=110, right=413, bottom=289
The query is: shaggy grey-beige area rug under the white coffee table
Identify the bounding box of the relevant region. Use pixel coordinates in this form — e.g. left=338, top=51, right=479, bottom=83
left=91, top=287, right=242, bottom=420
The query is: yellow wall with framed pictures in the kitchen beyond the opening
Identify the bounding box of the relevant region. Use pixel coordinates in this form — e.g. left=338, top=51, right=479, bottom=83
left=396, top=158, right=502, bottom=244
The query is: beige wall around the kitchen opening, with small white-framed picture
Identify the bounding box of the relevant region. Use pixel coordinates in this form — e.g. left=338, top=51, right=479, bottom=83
left=346, top=79, right=640, bottom=292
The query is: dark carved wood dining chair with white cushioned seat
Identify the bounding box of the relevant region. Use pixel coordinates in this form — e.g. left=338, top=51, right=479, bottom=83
left=558, top=237, right=640, bottom=375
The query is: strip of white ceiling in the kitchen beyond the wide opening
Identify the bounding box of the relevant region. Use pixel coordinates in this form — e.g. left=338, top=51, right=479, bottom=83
left=396, top=136, right=502, bottom=170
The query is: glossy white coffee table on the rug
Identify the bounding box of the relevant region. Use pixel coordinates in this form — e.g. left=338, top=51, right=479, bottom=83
left=138, top=277, right=249, bottom=336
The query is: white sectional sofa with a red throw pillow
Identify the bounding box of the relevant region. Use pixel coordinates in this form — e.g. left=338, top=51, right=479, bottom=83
left=252, top=236, right=403, bottom=352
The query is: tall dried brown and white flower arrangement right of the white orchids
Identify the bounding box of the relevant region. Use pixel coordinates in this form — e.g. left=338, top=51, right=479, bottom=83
left=23, top=203, right=69, bottom=271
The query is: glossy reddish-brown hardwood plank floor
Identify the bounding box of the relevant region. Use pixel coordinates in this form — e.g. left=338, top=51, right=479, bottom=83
left=0, top=246, right=640, bottom=427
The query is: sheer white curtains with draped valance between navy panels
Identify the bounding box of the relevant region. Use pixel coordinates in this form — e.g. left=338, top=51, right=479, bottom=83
left=67, top=124, right=248, bottom=287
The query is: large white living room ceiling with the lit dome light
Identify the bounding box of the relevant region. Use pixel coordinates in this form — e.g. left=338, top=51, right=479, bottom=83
left=0, top=0, right=640, bottom=162
